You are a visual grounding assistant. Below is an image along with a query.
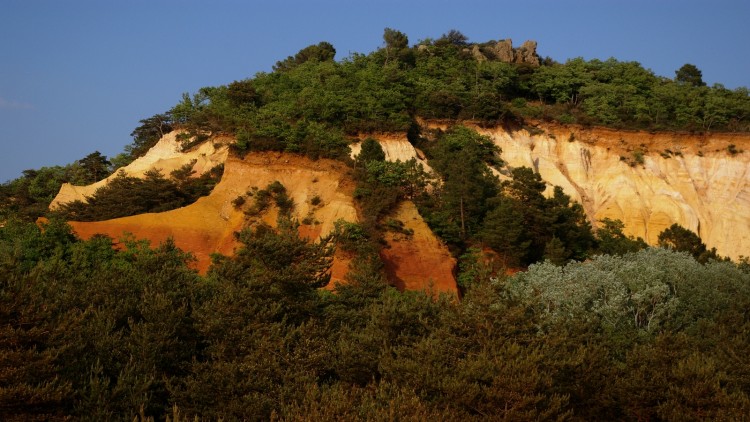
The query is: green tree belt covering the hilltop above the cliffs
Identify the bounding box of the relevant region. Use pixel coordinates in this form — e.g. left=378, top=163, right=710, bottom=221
left=0, top=28, right=750, bottom=223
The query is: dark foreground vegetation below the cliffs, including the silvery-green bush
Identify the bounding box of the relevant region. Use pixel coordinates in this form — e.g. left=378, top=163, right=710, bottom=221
left=0, top=216, right=750, bottom=420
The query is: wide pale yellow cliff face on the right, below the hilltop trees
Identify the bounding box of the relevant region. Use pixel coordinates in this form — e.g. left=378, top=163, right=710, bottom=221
left=477, top=123, right=750, bottom=259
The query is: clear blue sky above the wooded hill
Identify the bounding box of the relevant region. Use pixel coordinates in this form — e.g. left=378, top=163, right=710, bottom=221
left=0, top=0, right=750, bottom=183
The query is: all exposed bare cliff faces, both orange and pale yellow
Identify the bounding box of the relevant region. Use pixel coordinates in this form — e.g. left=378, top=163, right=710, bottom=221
left=53, top=124, right=750, bottom=292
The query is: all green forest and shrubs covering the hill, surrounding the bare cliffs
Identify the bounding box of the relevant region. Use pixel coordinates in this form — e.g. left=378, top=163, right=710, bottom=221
left=0, top=29, right=750, bottom=421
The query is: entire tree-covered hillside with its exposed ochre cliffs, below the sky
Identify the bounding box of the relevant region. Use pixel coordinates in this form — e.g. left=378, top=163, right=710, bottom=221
left=0, top=28, right=750, bottom=422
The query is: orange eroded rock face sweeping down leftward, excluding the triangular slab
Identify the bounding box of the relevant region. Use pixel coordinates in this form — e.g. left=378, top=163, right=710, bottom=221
left=70, top=154, right=357, bottom=281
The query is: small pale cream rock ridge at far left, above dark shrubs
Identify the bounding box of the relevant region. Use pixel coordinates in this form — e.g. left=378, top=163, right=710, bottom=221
left=50, top=131, right=229, bottom=210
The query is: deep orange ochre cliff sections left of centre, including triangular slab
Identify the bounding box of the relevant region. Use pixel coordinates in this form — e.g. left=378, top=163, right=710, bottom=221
left=60, top=147, right=457, bottom=294
